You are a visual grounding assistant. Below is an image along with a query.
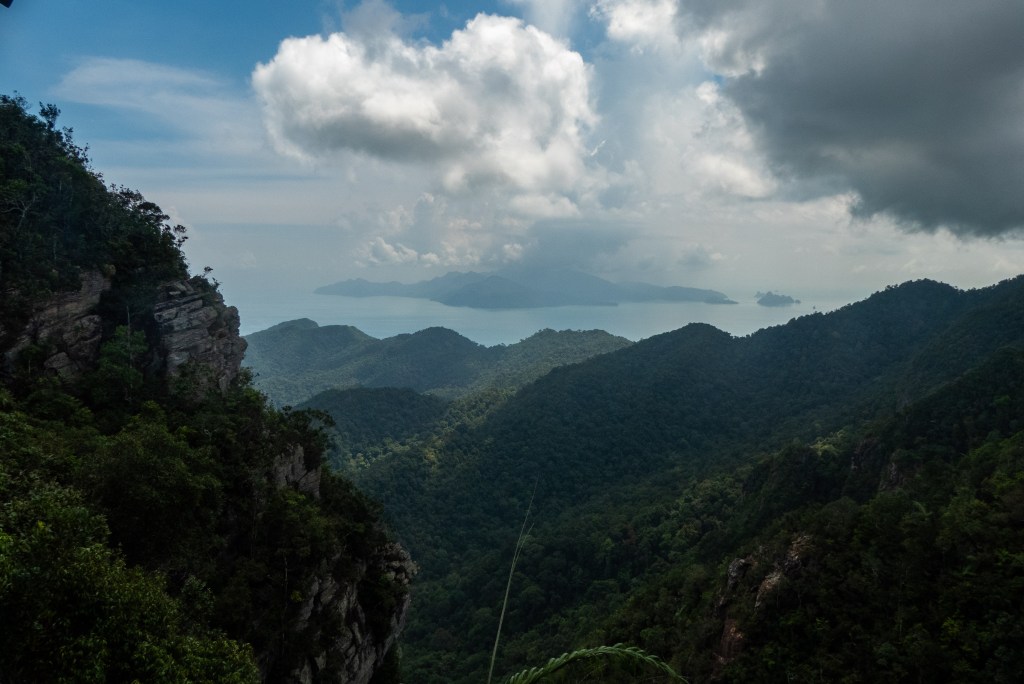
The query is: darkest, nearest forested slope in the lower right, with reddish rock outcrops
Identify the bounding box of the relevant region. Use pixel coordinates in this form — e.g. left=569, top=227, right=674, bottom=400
left=592, top=348, right=1024, bottom=682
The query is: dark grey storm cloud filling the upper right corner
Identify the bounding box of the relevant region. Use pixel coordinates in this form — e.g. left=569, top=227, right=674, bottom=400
left=679, top=0, right=1024, bottom=236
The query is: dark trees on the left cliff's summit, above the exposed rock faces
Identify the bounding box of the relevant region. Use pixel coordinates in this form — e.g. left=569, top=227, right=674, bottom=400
left=0, top=95, right=187, bottom=349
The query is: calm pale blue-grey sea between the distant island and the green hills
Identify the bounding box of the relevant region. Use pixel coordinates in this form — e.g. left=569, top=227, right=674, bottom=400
left=224, top=292, right=848, bottom=346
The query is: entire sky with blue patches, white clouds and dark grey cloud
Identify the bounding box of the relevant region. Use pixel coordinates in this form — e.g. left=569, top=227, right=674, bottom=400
left=0, top=0, right=1024, bottom=301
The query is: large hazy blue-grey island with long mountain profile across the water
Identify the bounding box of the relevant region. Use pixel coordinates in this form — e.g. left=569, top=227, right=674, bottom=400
left=314, top=268, right=736, bottom=309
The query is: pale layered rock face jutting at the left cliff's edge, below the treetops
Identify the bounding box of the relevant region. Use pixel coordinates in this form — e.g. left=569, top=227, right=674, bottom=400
left=153, top=277, right=246, bottom=392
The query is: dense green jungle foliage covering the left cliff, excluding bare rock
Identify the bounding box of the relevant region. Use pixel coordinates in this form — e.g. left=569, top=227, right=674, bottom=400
left=0, top=96, right=403, bottom=682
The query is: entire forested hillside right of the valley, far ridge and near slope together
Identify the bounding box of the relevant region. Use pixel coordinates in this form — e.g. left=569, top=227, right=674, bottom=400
left=342, top=270, right=1024, bottom=682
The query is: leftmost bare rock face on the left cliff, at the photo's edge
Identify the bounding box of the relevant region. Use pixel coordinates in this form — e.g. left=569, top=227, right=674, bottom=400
left=3, top=272, right=111, bottom=379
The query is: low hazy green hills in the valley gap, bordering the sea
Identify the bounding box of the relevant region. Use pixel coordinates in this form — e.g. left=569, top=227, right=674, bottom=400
left=246, top=318, right=631, bottom=405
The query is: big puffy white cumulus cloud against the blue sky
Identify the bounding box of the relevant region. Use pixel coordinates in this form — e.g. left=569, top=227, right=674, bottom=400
left=252, top=14, right=597, bottom=202
